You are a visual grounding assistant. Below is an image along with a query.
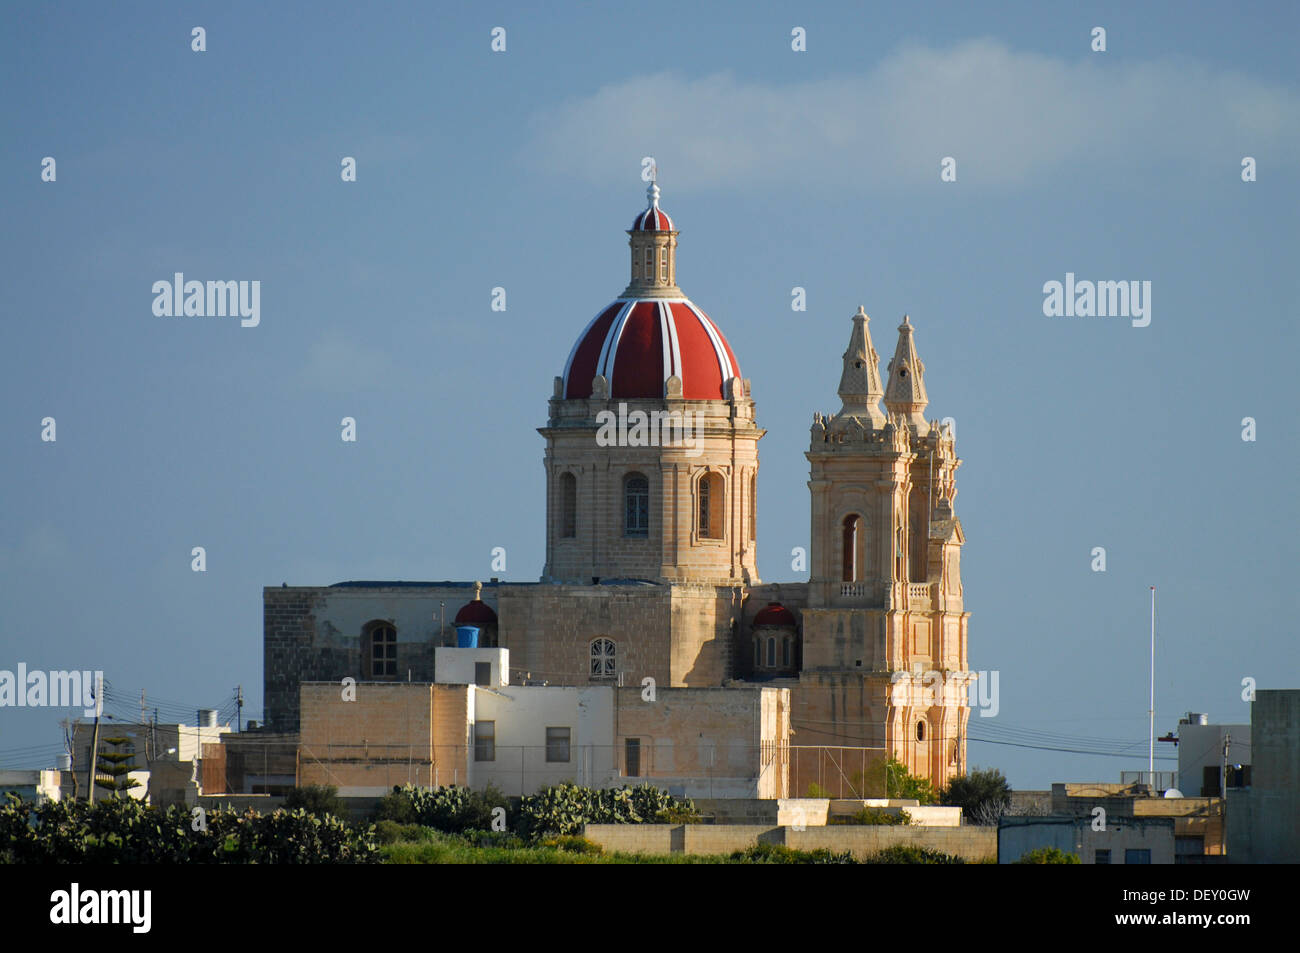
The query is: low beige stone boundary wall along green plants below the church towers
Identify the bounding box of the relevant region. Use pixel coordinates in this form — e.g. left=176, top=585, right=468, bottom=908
left=582, top=824, right=997, bottom=862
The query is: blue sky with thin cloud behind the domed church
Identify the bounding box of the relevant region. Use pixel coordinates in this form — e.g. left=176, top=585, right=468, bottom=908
left=0, top=3, right=1300, bottom=789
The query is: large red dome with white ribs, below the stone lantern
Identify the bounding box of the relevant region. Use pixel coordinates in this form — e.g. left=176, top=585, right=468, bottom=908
left=564, top=298, right=740, bottom=400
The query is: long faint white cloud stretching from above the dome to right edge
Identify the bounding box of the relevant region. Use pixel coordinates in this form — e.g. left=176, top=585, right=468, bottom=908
left=528, top=39, right=1300, bottom=191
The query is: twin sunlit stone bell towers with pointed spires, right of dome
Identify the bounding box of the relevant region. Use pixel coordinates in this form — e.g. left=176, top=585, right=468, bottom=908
left=794, top=307, right=970, bottom=787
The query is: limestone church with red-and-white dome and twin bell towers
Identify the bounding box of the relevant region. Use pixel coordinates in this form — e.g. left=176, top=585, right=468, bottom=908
left=263, top=183, right=974, bottom=793
